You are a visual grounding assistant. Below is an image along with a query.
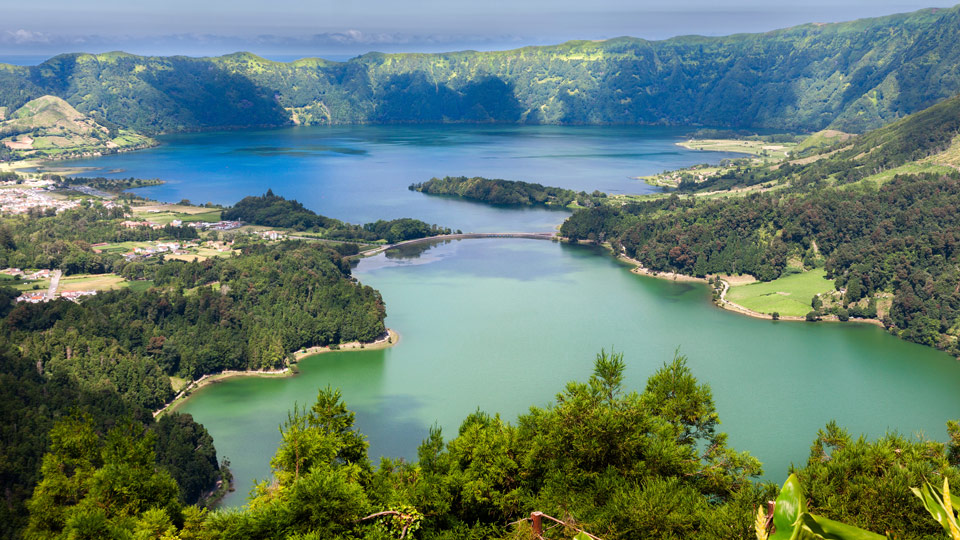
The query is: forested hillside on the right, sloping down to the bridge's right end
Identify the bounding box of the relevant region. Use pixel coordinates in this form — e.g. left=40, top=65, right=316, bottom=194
left=560, top=89, right=960, bottom=356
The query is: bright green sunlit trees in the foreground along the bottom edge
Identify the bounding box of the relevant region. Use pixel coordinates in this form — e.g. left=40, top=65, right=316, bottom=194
left=13, top=353, right=960, bottom=540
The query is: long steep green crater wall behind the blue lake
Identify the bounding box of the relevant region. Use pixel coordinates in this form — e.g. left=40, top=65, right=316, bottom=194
left=0, top=8, right=960, bottom=133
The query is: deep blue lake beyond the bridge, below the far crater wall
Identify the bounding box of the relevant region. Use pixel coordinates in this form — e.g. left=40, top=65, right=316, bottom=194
left=62, top=125, right=734, bottom=232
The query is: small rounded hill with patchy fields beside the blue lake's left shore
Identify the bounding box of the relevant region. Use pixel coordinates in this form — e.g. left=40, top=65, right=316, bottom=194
left=0, top=96, right=153, bottom=157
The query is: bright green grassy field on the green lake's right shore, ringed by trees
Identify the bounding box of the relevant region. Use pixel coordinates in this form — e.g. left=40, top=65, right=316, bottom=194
left=727, top=268, right=834, bottom=317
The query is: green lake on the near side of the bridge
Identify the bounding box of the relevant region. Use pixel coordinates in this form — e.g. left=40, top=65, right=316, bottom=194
left=179, top=239, right=960, bottom=506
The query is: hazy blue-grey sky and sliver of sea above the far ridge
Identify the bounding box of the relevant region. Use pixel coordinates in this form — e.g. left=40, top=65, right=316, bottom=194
left=0, top=0, right=958, bottom=59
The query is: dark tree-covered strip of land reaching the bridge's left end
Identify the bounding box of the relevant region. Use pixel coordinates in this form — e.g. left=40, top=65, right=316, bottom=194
left=222, top=190, right=451, bottom=244
